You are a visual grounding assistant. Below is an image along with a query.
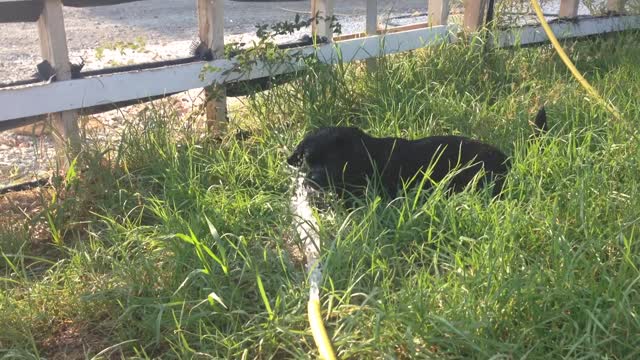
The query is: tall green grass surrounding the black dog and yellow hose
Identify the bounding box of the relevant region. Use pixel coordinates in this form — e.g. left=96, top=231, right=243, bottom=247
left=0, top=32, right=640, bottom=359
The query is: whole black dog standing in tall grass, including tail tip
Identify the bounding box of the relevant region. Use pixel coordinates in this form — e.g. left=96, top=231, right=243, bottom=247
left=287, top=108, right=547, bottom=196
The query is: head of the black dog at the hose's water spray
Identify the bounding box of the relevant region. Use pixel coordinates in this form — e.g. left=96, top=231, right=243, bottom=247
left=287, top=127, right=371, bottom=193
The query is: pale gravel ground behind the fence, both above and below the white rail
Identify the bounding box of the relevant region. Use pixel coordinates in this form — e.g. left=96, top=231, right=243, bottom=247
left=0, top=0, right=586, bottom=187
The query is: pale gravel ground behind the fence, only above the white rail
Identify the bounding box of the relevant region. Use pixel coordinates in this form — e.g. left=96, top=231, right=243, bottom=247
left=0, top=0, right=436, bottom=83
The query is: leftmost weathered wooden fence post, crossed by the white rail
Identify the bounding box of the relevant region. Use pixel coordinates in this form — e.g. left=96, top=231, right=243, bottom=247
left=38, top=0, right=80, bottom=171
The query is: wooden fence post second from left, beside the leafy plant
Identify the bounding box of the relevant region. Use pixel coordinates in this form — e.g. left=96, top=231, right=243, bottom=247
left=197, top=0, right=227, bottom=135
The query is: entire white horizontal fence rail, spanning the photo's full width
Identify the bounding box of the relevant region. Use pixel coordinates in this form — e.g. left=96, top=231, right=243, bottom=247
left=0, top=16, right=640, bottom=122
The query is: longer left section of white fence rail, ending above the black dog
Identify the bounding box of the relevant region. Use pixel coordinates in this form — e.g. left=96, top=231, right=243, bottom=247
left=0, top=26, right=456, bottom=121
